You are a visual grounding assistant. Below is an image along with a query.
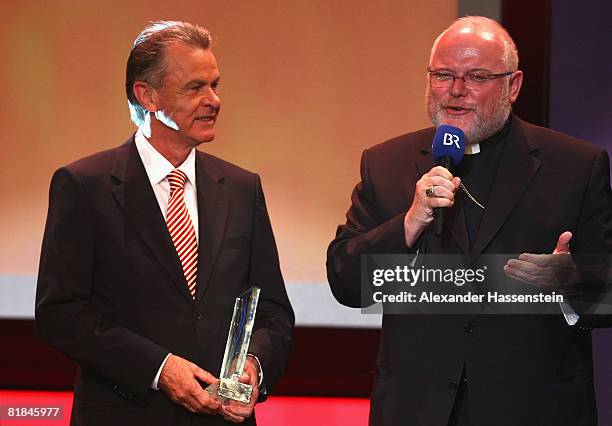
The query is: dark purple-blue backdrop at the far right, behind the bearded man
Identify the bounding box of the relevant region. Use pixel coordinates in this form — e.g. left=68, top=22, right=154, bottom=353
left=550, top=0, right=612, bottom=425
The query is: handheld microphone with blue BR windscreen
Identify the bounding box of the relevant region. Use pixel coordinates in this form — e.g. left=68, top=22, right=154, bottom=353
left=431, top=124, right=465, bottom=236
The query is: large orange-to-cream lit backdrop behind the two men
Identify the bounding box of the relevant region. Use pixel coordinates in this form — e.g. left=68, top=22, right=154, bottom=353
left=0, top=0, right=457, bottom=300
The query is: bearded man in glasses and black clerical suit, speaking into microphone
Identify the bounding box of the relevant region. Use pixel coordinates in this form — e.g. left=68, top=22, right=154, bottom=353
left=327, top=17, right=612, bottom=426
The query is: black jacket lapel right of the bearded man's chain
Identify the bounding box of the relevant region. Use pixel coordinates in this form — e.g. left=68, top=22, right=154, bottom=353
left=472, top=117, right=541, bottom=256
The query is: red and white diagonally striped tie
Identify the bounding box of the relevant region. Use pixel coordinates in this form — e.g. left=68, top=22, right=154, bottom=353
left=166, top=169, right=198, bottom=299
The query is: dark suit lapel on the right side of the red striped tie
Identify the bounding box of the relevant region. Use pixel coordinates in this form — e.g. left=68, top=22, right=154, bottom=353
left=196, top=152, right=229, bottom=304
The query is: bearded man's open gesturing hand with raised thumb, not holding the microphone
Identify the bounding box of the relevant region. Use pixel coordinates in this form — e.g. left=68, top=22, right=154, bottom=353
left=504, top=231, right=579, bottom=295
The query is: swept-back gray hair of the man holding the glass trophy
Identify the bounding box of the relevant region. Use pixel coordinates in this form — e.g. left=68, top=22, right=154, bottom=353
left=125, top=21, right=211, bottom=126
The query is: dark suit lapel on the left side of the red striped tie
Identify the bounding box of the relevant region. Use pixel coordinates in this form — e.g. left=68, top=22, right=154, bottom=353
left=111, top=137, right=192, bottom=302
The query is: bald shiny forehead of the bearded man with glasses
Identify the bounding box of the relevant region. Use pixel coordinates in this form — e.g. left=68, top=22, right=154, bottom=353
left=430, top=26, right=505, bottom=70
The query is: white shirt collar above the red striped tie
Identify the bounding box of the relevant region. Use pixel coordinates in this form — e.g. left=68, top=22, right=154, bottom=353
left=134, top=129, right=195, bottom=187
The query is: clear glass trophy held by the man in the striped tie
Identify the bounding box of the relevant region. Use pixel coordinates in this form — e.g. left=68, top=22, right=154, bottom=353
left=206, top=287, right=261, bottom=404
